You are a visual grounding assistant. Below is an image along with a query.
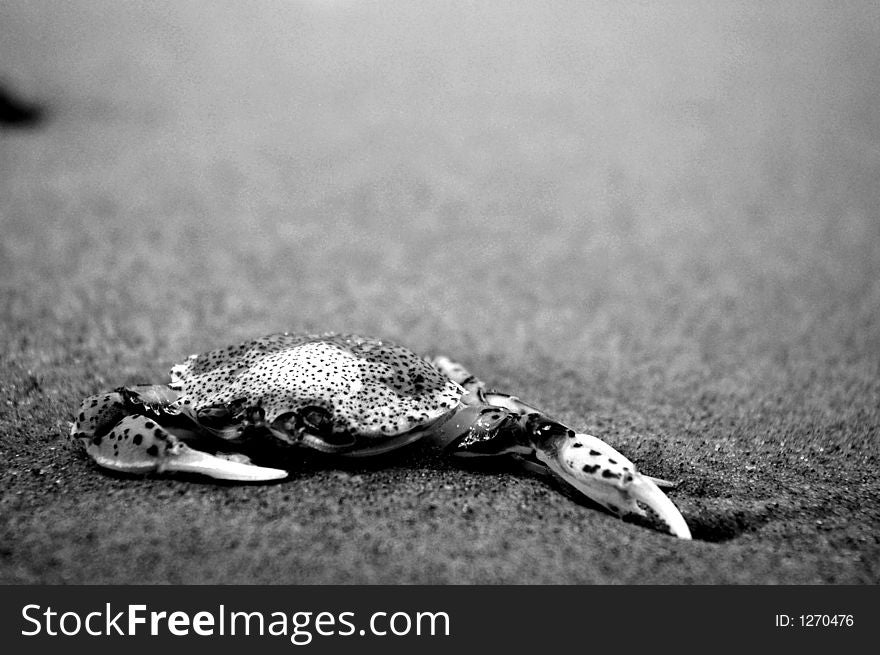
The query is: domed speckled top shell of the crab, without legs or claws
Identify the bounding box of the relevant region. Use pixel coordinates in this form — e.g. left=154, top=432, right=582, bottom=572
left=170, top=333, right=464, bottom=440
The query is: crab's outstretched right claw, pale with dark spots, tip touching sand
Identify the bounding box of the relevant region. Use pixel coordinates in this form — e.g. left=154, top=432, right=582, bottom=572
left=533, top=430, right=691, bottom=539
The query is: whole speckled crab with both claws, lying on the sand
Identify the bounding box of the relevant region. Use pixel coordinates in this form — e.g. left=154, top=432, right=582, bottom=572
left=71, top=332, right=691, bottom=539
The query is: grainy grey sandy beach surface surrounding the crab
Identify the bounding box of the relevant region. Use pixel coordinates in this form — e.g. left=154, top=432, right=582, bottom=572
left=0, top=0, right=880, bottom=584
